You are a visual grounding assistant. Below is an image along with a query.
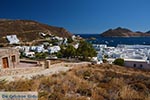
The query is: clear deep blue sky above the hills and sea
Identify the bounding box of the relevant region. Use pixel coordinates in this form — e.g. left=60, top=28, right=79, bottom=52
left=0, top=0, right=150, bottom=34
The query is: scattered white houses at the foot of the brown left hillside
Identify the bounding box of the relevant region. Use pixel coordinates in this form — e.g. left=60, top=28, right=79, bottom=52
left=7, top=33, right=79, bottom=58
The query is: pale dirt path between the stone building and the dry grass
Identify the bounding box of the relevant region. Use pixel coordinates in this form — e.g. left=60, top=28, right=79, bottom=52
left=0, top=62, right=90, bottom=82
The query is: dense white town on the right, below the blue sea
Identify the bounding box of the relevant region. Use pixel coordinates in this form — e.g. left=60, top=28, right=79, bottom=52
left=93, top=44, right=150, bottom=70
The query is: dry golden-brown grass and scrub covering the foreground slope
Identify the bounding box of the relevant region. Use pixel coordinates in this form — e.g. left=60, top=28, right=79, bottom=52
left=0, top=64, right=150, bottom=100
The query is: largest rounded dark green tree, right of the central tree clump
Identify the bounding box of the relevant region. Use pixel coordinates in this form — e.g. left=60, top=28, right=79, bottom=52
left=77, top=41, right=97, bottom=60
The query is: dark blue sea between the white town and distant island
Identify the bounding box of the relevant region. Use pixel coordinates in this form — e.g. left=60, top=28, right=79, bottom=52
left=78, top=34, right=150, bottom=47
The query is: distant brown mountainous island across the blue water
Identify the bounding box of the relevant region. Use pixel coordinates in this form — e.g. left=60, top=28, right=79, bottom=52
left=100, top=27, right=150, bottom=37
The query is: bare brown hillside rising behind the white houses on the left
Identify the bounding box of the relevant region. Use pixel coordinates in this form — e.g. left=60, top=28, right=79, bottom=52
left=0, top=19, right=72, bottom=43
